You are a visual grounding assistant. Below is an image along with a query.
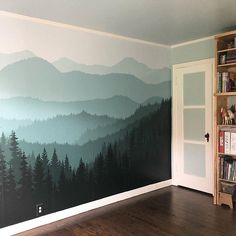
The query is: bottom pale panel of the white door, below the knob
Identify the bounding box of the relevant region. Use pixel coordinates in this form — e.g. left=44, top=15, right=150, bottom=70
left=184, top=143, right=206, bottom=177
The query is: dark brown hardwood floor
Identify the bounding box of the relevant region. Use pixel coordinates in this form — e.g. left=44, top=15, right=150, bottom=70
left=18, top=187, right=236, bottom=236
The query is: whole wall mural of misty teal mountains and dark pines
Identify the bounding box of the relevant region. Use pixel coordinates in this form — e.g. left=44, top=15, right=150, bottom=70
left=0, top=16, right=171, bottom=227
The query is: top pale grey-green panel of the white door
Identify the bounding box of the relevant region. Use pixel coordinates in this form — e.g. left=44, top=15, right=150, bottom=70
left=183, top=72, right=205, bottom=106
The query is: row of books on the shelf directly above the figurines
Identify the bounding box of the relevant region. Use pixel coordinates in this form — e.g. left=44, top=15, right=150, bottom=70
left=217, top=72, right=236, bottom=93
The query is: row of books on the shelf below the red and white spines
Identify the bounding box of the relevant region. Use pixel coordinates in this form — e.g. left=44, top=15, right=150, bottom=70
left=220, top=156, right=236, bottom=181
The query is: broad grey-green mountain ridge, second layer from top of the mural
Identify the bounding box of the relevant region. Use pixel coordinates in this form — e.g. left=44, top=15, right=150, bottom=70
left=0, top=57, right=170, bottom=103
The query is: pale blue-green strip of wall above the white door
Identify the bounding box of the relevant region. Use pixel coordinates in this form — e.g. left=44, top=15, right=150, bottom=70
left=171, top=39, right=215, bottom=65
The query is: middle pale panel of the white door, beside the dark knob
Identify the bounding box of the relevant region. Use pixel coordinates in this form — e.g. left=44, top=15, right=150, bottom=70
left=184, top=108, right=205, bottom=141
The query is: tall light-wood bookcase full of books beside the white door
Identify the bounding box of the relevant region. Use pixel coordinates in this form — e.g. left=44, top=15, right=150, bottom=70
left=214, top=31, right=236, bottom=208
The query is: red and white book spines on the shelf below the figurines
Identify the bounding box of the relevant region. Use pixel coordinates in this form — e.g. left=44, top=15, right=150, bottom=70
left=219, top=129, right=236, bottom=154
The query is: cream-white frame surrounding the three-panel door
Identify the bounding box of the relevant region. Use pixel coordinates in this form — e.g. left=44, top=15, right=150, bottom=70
left=171, top=58, right=215, bottom=193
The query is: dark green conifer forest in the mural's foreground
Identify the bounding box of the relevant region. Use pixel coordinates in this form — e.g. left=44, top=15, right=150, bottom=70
left=0, top=100, right=171, bottom=227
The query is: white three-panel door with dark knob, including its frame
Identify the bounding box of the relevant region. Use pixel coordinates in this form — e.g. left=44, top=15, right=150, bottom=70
left=172, top=59, right=213, bottom=193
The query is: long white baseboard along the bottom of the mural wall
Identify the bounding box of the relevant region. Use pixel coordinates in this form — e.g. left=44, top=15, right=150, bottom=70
left=0, top=179, right=172, bottom=236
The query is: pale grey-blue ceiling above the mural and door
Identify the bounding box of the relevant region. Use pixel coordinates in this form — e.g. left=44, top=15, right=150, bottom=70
left=0, top=0, right=236, bottom=45
